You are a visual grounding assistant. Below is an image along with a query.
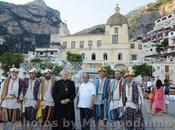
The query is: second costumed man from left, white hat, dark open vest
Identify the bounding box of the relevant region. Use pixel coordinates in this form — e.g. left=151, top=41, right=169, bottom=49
left=23, top=68, right=40, bottom=130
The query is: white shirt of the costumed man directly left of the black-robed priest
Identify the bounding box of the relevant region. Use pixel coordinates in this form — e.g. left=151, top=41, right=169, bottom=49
left=43, top=79, right=54, bottom=106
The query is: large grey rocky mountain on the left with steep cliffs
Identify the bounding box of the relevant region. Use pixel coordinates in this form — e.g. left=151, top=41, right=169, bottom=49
left=0, top=0, right=68, bottom=52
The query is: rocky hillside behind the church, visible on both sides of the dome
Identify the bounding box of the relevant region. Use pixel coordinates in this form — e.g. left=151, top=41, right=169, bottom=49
left=76, top=0, right=175, bottom=40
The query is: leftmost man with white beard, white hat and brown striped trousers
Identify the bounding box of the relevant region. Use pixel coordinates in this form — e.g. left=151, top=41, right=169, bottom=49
left=0, top=68, right=22, bottom=129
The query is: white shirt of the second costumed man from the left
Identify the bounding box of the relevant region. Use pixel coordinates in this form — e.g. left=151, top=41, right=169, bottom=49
left=25, top=79, right=36, bottom=108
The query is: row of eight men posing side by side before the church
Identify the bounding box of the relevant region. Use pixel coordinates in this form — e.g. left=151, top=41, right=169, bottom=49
left=0, top=68, right=144, bottom=130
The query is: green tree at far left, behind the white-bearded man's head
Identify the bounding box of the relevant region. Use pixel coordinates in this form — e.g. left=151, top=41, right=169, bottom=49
left=0, top=52, right=24, bottom=73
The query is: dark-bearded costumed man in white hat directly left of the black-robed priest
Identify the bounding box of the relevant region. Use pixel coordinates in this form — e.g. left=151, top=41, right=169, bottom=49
left=40, top=69, right=55, bottom=129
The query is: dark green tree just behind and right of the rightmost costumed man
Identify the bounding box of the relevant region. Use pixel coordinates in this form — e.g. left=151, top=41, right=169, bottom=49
left=132, top=63, right=155, bottom=76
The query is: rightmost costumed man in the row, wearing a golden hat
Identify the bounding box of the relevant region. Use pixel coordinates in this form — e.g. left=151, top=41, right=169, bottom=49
left=122, top=71, right=145, bottom=130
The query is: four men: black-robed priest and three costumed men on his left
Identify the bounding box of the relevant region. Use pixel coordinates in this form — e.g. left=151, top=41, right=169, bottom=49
left=0, top=68, right=76, bottom=130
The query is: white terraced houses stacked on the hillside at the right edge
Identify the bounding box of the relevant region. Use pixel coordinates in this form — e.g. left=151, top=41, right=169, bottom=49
left=143, top=13, right=175, bottom=83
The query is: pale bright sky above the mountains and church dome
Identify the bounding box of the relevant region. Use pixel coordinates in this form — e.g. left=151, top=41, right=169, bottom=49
left=0, top=0, right=155, bottom=34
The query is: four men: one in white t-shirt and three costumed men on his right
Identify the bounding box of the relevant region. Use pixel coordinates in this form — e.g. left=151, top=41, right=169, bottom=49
left=77, top=68, right=144, bottom=130
